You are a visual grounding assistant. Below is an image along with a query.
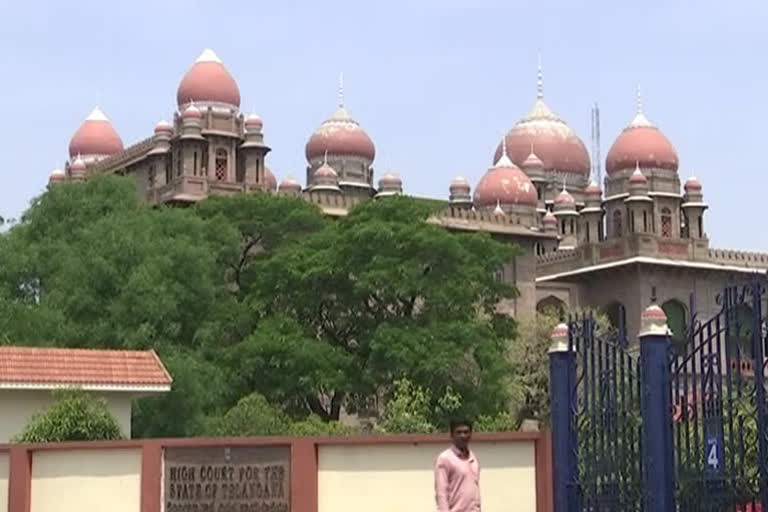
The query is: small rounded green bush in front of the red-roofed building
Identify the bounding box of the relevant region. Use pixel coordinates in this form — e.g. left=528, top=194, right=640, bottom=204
left=13, top=391, right=123, bottom=443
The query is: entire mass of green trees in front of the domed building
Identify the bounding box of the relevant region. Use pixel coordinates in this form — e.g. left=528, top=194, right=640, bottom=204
left=0, top=176, right=528, bottom=436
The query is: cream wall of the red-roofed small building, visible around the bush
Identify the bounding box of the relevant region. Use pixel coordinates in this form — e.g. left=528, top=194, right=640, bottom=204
left=0, top=389, right=136, bottom=443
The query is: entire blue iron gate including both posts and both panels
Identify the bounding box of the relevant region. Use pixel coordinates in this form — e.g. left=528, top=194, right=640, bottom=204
left=550, top=275, right=768, bottom=512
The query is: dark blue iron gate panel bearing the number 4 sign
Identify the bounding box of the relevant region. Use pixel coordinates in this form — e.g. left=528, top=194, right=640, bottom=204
left=670, top=279, right=768, bottom=512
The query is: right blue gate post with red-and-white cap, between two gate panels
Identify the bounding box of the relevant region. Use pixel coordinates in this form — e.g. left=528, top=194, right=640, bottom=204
left=639, top=304, right=675, bottom=512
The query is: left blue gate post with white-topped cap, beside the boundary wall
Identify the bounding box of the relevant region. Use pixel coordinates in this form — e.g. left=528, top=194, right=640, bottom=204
left=549, top=324, right=578, bottom=512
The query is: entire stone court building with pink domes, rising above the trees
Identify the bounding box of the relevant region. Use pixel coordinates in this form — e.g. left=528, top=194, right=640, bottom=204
left=50, top=50, right=768, bottom=336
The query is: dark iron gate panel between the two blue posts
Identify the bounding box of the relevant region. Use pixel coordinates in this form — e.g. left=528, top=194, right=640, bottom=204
left=568, top=315, right=644, bottom=512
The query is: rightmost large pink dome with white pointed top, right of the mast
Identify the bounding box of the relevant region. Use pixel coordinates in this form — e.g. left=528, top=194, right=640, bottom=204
left=605, top=98, right=679, bottom=174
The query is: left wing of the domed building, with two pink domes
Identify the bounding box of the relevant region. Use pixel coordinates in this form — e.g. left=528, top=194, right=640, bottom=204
left=57, top=49, right=277, bottom=203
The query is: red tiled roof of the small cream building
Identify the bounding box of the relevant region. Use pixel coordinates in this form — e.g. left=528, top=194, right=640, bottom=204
left=0, top=346, right=172, bottom=391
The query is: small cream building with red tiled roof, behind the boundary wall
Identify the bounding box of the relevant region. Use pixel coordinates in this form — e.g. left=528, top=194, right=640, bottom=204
left=0, top=346, right=172, bottom=443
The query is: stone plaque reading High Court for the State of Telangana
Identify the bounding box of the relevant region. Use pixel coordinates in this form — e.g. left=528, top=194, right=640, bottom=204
left=163, top=447, right=290, bottom=512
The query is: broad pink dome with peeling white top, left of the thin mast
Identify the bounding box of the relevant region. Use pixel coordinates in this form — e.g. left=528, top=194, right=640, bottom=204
left=494, top=97, right=590, bottom=176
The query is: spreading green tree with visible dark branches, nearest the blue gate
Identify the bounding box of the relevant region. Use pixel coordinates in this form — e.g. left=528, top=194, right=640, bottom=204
left=238, top=197, right=517, bottom=420
